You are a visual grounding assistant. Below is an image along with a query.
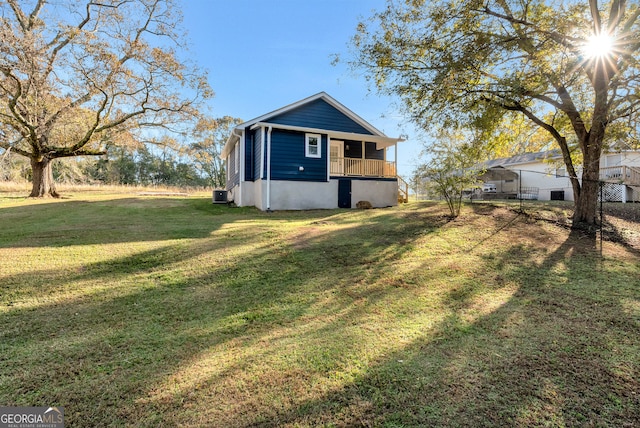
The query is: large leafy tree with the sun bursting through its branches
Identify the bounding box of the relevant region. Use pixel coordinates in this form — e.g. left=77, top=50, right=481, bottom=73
left=351, top=0, right=640, bottom=225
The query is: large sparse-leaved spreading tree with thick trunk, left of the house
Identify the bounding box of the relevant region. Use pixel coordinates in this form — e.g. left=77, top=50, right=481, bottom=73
left=0, top=0, right=212, bottom=196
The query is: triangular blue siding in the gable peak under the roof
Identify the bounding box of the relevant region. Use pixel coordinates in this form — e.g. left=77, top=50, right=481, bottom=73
left=268, top=99, right=372, bottom=135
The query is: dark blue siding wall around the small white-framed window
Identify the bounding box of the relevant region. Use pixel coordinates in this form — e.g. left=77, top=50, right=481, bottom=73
left=271, top=129, right=328, bottom=181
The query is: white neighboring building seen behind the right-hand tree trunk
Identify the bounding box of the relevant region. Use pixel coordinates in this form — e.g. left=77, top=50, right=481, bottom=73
left=481, top=150, right=640, bottom=202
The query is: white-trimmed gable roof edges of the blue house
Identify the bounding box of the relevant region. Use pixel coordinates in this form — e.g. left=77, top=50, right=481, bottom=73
left=221, top=92, right=402, bottom=158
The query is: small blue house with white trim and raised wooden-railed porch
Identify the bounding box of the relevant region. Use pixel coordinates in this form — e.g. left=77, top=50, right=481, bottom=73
left=222, top=92, right=402, bottom=210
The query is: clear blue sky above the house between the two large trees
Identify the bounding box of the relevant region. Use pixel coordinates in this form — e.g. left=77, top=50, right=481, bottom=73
left=182, top=0, right=421, bottom=178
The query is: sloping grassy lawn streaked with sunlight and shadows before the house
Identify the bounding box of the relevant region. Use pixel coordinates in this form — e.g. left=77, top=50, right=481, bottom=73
left=0, top=190, right=640, bottom=427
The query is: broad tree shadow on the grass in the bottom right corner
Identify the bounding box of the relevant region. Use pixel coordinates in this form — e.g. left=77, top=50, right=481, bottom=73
left=256, top=232, right=640, bottom=427
